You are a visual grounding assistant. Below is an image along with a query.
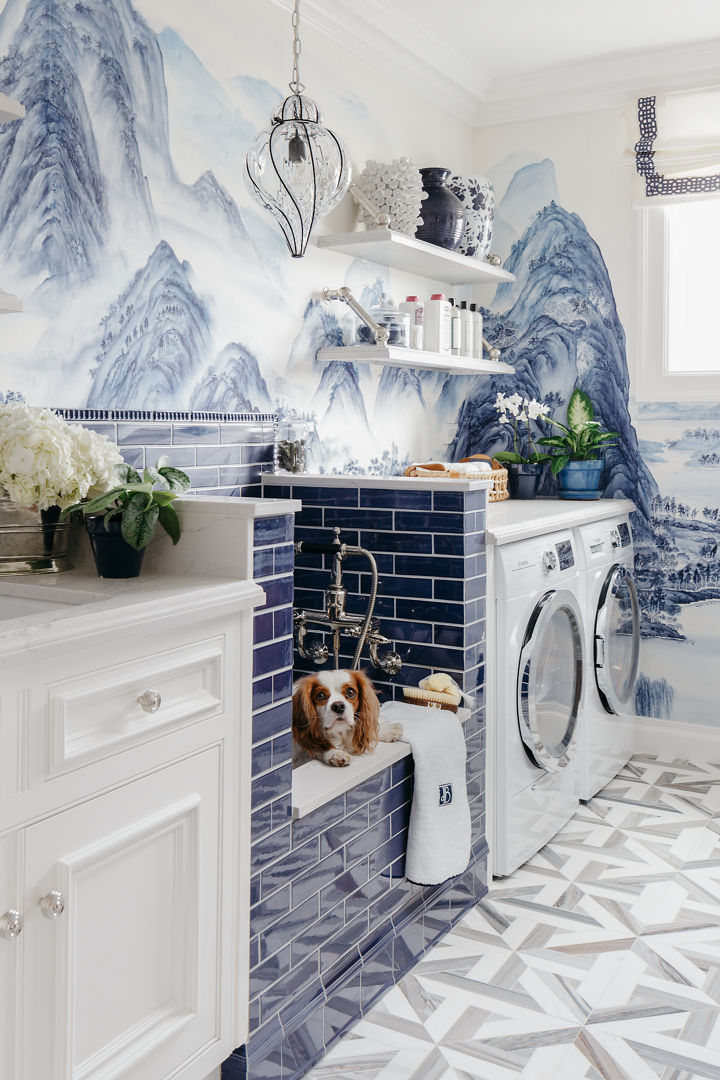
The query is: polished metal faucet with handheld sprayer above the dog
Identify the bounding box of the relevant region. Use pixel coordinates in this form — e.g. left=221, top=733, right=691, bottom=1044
left=293, top=527, right=403, bottom=675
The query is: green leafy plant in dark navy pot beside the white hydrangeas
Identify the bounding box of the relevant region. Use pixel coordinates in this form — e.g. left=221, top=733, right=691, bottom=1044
left=62, top=458, right=190, bottom=578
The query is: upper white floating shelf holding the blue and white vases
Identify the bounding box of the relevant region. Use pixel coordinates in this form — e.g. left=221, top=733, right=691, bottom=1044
left=316, top=229, right=515, bottom=285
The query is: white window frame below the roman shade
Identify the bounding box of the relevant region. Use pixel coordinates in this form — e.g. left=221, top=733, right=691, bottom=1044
left=634, top=194, right=720, bottom=402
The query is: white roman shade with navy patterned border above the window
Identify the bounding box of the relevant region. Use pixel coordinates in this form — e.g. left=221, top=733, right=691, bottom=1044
left=634, top=87, right=720, bottom=198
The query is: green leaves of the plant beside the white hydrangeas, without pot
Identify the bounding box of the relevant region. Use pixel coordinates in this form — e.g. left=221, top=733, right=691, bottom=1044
left=60, top=458, right=190, bottom=551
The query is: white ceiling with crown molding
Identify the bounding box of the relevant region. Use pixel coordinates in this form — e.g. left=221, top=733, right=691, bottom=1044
left=267, top=0, right=720, bottom=124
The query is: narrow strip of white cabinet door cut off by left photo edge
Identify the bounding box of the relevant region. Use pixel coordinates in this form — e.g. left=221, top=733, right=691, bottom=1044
left=0, top=833, right=24, bottom=1078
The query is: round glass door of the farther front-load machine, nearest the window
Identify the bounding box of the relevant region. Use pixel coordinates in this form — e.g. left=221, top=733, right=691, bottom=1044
left=595, top=563, right=640, bottom=714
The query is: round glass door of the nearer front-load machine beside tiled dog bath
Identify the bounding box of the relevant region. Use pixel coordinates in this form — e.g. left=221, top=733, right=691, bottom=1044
left=517, top=592, right=583, bottom=772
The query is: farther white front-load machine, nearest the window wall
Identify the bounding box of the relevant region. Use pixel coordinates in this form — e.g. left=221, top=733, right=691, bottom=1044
left=575, top=513, right=640, bottom=799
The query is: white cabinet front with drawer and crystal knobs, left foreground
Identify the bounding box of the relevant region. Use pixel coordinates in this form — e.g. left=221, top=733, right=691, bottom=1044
left=0, top=582, right=262, bottom=1080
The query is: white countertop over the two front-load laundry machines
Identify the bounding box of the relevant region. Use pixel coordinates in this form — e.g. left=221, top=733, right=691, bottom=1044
left=486, top=499, right=636, bottom=544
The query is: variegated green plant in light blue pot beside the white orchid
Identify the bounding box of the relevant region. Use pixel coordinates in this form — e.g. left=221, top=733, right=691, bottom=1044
left=538, top=387, right=620, bottom=499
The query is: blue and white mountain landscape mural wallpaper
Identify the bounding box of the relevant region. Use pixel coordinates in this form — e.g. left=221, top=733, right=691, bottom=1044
left=0, top=0, right=720, bottom=724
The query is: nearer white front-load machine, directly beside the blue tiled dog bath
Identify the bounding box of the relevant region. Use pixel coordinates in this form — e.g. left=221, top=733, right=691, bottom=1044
left=491, top=529, right=585, bottom=876
